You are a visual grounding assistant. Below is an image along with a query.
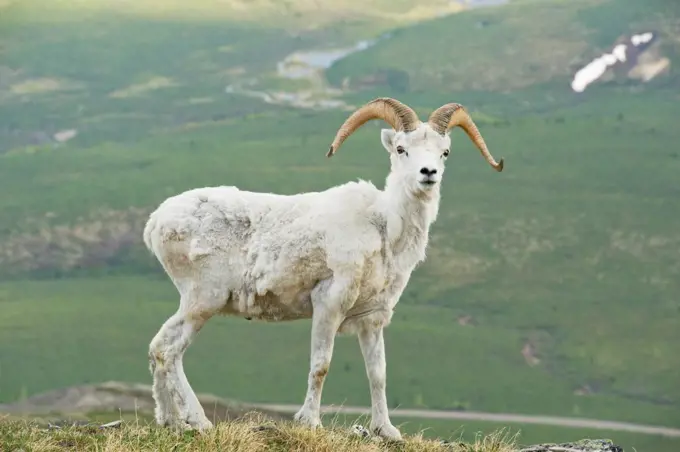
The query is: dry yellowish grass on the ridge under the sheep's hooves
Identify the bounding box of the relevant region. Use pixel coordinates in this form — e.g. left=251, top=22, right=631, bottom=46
left=0, top=415, right=516, bottom=452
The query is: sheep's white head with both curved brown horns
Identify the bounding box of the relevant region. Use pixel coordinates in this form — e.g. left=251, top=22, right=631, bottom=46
left=327, top=97, right=503, bottom=190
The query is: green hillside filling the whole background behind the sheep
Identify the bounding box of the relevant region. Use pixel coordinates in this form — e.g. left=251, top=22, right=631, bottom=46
left=0, top=0, right=680, bottom=450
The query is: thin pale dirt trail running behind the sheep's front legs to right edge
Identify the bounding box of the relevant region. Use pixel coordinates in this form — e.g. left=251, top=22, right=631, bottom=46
left=256, top=404, right=680, bottom=438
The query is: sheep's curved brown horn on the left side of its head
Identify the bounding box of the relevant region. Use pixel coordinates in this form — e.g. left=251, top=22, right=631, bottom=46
left=326, top=97, right=420, bottom=157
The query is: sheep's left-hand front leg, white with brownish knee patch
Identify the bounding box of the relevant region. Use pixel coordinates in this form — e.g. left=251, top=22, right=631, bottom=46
left=294, top=305, right=342, bottom=427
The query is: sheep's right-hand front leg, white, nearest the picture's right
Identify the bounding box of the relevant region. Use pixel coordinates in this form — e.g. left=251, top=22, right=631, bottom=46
left=359, top=327, right=401, bottom=440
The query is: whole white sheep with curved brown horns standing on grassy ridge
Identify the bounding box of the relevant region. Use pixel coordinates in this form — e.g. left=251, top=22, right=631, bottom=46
left=144, top=98, right=503, bottom=439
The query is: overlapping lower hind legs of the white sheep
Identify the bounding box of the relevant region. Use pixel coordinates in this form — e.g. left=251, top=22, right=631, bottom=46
left=150, top=300, right=214, bottom=430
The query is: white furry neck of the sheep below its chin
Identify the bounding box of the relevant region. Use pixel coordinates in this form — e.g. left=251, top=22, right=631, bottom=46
left=382, top=175, right=440, bottom=260
